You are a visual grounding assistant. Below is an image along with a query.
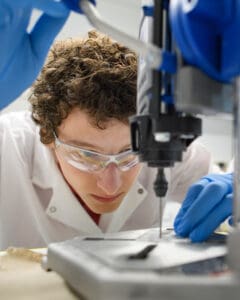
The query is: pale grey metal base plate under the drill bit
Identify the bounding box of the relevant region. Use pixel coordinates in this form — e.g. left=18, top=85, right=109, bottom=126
left=43, top=228, right=240, bottom=300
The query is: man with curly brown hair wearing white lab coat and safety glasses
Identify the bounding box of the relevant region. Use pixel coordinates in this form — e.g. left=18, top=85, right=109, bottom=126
left=0, top=31, right=214, bottom=249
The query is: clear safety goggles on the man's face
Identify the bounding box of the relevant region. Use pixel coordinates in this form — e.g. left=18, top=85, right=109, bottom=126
left=54, top=133, right=139, bottom=172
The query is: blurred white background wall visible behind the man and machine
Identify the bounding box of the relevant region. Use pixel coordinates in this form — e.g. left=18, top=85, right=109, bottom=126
left=3, top=0, right=232, bottom=166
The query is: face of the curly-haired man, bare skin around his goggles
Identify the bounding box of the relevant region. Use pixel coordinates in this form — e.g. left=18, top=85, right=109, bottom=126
left=52, top=109, right=141, bottom=214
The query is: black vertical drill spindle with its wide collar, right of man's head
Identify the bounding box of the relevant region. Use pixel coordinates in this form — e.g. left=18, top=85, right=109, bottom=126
left=130, top=0, right=201, bottom=175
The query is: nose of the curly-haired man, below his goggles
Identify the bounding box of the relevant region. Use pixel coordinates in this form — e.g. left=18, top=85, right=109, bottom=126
left=97, top=163, right=122, bottom=195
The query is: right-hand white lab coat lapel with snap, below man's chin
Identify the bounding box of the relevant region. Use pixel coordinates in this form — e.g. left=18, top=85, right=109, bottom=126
left=100, top=182, right=147, bottom=232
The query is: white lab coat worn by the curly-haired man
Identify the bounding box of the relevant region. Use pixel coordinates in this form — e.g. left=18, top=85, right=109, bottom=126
left=0, top=112, right=214, bottom=249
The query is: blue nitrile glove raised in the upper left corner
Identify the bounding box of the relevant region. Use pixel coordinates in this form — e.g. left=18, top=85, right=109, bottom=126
left=0, top=0, right=69, bottom=109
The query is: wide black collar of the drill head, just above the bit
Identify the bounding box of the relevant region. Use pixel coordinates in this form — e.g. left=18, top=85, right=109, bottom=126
left=130, top=114, right=201, bottom=168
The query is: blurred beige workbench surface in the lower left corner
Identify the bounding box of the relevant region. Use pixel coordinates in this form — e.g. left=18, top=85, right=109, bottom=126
left=0, top=248, right=80, bottom=300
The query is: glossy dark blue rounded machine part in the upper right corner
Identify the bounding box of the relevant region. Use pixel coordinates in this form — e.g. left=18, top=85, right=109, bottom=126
left=169, top=0, right=240, bottom=82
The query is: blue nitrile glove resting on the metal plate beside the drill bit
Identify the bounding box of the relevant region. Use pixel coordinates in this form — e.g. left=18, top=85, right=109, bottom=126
left=174, top=173, right=233, bottom=242
